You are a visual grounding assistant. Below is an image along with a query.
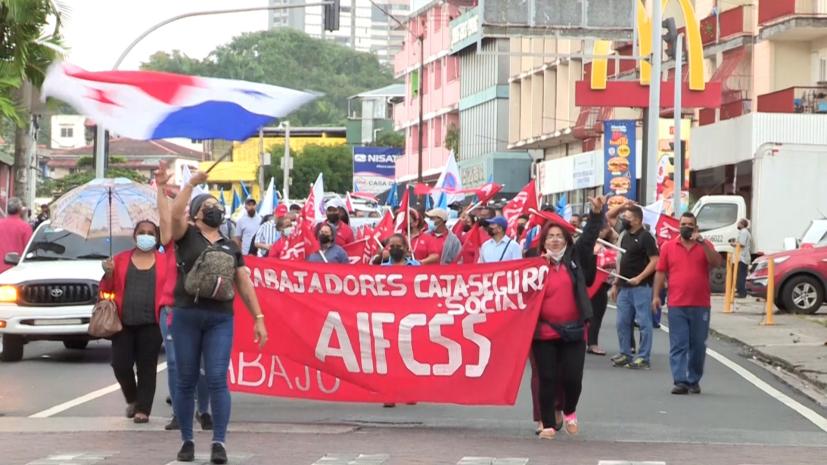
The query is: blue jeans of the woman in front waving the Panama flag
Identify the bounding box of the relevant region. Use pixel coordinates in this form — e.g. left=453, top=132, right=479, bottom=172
left=172, top=308, right=233, bottom=443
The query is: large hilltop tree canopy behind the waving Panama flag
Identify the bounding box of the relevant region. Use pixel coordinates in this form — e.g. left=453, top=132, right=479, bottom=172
left=141, top=28, right=394, bottom=126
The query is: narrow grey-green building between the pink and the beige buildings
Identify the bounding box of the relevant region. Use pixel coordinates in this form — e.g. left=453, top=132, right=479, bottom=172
left=451, top=7, right=532, bottom=195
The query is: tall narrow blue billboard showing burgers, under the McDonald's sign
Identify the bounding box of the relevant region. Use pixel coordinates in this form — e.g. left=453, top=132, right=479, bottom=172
left=603, top=120, right=637, bottom=208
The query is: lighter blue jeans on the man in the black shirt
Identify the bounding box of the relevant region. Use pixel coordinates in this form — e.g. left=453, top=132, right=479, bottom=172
left=617, top=285, right=653, bottom=362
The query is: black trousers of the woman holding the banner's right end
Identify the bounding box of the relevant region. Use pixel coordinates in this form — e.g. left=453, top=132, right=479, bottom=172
left=531, top=339, right=586, bottom=427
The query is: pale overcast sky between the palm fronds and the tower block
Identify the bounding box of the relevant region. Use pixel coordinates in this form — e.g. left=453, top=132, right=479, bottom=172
left=61, top=0, right=268, bottom=71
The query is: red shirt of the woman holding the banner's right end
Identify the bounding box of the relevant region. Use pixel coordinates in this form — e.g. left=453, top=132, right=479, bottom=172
left=537, top=265, right=580, bottom=341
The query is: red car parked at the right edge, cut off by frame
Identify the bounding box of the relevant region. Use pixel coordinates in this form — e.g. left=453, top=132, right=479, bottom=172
left=747, top=245, right=827, bottom=314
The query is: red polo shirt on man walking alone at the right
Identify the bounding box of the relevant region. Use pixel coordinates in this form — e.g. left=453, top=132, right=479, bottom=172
left=656, top=237, right=714, bottom=307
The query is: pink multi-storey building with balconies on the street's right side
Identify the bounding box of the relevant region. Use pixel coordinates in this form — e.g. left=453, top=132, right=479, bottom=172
left=393, top=0, right=468, bottom=182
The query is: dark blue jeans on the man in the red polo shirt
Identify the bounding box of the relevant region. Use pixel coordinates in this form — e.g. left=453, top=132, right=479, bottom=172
left=669, top=305, right=710, bottom=386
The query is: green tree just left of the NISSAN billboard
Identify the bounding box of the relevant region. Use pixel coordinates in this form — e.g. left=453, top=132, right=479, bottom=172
left=270, top=144, right=353, bottom=199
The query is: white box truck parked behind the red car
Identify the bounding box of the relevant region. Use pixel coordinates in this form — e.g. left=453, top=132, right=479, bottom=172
left=692, top=144, right=827, bottom=292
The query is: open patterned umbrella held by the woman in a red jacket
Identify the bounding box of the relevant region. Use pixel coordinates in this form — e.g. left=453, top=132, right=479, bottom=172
left=52, top=178, right=158, bottom=255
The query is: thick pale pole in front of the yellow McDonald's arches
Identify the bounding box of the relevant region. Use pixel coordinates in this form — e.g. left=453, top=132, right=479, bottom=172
left=641, top=0, right=663, bottom=205
